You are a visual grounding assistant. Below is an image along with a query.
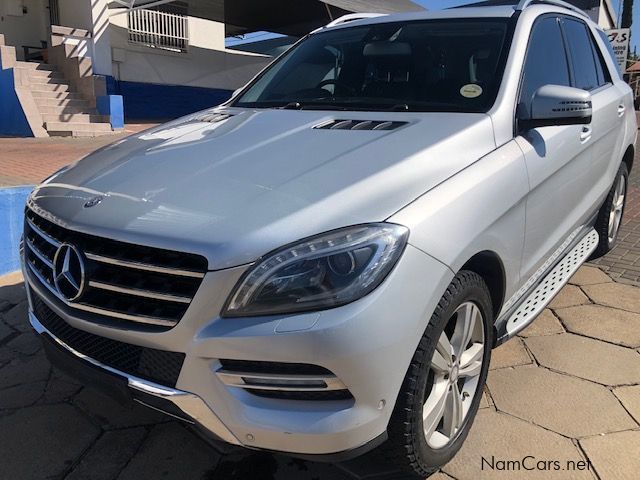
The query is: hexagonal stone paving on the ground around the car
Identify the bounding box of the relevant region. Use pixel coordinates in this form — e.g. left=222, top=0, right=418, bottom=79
left=0, top=266, right=640, bottom=480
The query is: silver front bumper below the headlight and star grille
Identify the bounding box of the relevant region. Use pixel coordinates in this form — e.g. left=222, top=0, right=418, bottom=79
left=25, top=246, right=453, bottom=460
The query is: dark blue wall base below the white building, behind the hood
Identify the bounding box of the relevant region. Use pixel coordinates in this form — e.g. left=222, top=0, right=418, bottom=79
left=107, top=77, right=233, bottom=121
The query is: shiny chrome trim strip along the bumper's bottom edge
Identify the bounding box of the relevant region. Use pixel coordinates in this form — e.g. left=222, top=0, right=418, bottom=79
left=29, top=311, right=242, bottom=445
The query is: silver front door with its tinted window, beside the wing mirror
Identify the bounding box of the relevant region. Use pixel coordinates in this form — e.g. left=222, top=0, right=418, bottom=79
left=516, top=15, right=597, bottom=279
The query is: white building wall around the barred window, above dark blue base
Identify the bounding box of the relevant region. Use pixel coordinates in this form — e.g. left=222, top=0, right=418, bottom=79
left=109, top=9, right=271, bottom=90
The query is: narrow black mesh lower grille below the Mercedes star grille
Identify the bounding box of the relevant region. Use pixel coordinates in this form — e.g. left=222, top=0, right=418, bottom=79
left=32, top=295, right=185, bottom=388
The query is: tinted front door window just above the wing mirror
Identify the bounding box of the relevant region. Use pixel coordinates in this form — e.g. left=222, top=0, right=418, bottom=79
left=520, top=17, right=571, bottom=104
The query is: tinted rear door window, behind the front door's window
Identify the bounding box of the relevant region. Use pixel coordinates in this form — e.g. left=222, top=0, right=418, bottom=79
left=563, top=19, right=604, bottom=90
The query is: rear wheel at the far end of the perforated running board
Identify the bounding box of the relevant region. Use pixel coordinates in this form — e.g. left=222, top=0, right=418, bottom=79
left=591, top=162, right=629, bottom=259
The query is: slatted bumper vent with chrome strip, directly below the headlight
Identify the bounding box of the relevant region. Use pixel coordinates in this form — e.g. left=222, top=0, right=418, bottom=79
left=216, top=359, right=353, bottom=401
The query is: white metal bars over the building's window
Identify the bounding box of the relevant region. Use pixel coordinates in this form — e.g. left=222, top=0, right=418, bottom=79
left=128, top=9, right=189, bottom=52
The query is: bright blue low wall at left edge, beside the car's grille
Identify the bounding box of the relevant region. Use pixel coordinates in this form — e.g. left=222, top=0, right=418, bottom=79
left=0, top=186, right=33, bottom=275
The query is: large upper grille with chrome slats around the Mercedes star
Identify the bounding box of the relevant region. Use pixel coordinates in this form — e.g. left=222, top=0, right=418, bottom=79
left=24, top=210, right=208, bottom=331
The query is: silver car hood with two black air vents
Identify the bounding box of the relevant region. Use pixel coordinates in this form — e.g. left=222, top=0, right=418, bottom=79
left=29, top=108, right=495, bottom=269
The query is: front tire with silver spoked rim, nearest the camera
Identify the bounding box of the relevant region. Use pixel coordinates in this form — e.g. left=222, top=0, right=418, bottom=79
left=380, top=271, right=493, bottom=479
